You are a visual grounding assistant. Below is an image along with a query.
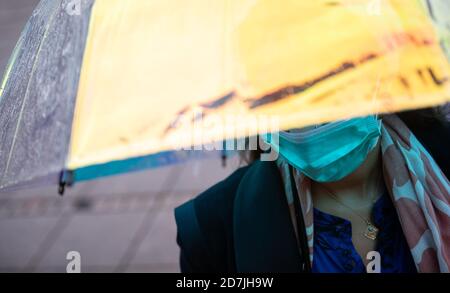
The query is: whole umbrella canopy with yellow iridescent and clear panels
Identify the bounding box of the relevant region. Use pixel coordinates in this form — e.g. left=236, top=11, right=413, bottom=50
left=0, top=0, right=450, bottom=192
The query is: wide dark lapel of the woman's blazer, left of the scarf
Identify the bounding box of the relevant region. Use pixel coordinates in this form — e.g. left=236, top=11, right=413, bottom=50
left=233, top=161, right=301, bottom=272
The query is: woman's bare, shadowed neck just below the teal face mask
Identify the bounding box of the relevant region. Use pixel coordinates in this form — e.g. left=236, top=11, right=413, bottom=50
left=321, top=143, right=382, bottom=200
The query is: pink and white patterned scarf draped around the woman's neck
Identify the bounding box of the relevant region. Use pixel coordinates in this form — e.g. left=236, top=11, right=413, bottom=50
left=277, top=115, right=450, bottom=273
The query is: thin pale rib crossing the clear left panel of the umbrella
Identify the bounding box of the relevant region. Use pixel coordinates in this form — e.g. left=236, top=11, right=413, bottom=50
left=0, top=3, right=58, bottom=187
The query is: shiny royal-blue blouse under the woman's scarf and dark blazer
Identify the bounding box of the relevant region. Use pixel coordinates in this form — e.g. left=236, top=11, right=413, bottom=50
left=312, top=192, right=417, bottom=273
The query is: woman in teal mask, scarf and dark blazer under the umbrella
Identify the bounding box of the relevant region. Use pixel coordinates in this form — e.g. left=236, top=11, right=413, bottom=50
left=175, top=109, right=450, bottom=273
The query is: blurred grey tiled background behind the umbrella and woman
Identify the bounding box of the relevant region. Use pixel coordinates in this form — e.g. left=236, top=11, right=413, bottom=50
left=0, top=0, right=238, bottom=273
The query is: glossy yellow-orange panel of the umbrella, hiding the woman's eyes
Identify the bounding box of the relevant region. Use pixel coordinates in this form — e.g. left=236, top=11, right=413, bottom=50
left=67, top=0, right=450, bottom=177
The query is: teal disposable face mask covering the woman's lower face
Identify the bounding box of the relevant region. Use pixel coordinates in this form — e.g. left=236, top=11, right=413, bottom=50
left=268, top=116, right=381, bottom=182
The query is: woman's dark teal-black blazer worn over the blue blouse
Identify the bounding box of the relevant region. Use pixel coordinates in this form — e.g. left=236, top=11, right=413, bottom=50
left=175, top=118, right=450, bottom=272
